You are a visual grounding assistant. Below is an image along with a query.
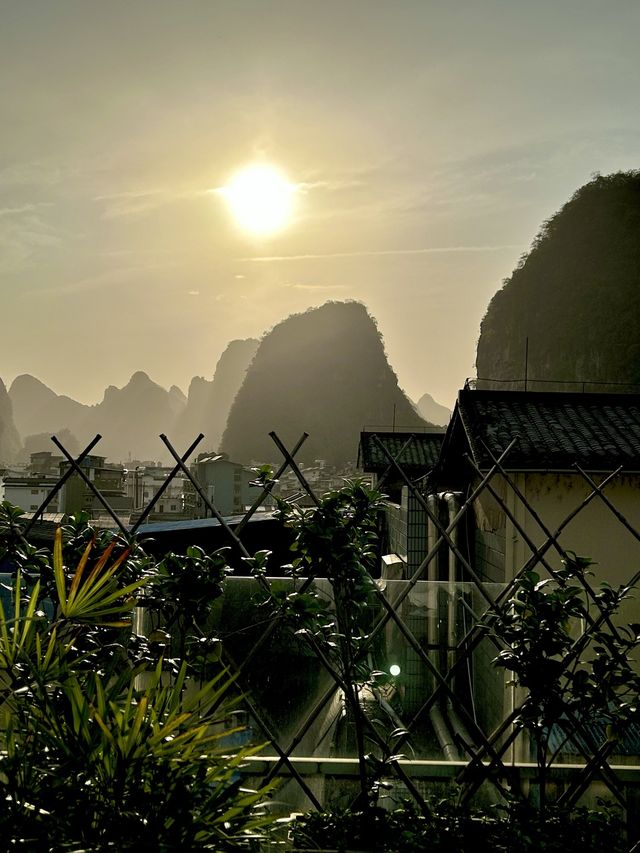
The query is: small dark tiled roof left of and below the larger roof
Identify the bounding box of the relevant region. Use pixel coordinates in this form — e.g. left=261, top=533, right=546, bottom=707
left=359, top=432, right=444, bottom=474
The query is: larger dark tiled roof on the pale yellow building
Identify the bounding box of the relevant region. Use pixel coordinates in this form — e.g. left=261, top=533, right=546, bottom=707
left=457, top=390, right=640, bottom=471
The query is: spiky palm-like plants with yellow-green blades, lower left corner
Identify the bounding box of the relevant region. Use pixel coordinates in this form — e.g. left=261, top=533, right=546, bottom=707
left=0, top=510, right=270, bottom=851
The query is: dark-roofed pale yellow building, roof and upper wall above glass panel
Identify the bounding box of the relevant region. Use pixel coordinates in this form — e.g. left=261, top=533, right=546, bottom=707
left=433, top=388, right=640, bottom=584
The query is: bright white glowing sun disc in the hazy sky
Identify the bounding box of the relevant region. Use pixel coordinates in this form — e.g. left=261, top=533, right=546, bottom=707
left=218, top=163, right=298, bottom=237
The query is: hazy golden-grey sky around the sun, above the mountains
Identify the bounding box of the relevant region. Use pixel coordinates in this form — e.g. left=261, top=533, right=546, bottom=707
left=0, top=0, right=640, bottom=407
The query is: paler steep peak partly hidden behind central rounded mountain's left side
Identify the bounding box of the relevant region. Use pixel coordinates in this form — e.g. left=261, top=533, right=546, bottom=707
left=174, top=338, right=259, bottom=450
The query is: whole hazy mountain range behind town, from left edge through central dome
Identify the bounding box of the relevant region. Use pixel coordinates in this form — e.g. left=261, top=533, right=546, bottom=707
left=0, top=302, right=444, bottom=466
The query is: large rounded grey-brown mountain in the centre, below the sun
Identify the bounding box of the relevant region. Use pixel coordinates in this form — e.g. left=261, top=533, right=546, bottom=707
left=221, top=302, right=426, bottom=466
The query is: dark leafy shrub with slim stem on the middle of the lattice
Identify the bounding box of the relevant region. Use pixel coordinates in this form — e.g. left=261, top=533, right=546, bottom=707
left=252, top=481, right=382, bottom=809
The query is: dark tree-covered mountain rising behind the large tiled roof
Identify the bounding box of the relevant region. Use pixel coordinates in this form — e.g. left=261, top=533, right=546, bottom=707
left=476, top=171, right=640, bottom=390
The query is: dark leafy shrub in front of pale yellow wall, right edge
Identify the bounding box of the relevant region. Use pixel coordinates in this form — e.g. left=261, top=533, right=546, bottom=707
left=489, top=552, right=640, bottom=812
